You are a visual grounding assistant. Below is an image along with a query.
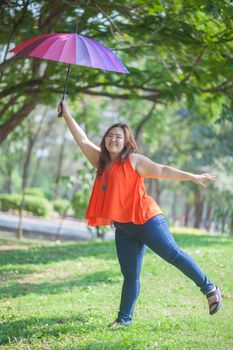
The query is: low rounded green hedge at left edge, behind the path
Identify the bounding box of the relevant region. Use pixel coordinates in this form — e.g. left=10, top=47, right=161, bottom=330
left=0, top=194, right=51, bottom=217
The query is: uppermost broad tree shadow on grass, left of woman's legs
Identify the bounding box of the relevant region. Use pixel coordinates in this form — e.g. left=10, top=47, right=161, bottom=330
left=0, top=241, right=115, bottom=266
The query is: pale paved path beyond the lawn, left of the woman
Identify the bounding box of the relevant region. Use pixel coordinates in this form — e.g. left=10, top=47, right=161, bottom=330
left=0, top=211, right=114, bottom=241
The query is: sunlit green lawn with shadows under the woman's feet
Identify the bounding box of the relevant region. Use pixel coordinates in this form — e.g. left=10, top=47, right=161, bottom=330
left=0, top=233, right=233, bottom=350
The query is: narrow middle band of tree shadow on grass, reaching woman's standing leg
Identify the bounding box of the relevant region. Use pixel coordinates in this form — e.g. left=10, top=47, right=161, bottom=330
left=0, top=270, right=119, bottom=298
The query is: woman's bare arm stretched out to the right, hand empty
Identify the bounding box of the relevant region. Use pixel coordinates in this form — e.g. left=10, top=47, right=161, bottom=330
left=130, top=153, right=215, bottom=187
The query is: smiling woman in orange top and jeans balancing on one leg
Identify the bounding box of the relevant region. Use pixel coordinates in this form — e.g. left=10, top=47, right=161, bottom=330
left=58, top=102, right=221, bottom=328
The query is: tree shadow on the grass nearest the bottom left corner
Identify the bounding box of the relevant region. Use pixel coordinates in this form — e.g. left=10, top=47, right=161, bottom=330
left=0, top=312, right=96, bottom=346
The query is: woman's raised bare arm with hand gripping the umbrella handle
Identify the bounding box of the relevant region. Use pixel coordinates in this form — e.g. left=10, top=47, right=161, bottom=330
left=58, top=101, right=100, bottom=168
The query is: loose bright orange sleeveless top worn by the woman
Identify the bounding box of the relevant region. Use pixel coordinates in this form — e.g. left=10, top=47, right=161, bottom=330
left=86, top=157, right=162, bottom=226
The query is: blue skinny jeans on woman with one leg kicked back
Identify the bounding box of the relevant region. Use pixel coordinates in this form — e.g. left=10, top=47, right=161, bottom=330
left=114, top=214, right=214, bottom=324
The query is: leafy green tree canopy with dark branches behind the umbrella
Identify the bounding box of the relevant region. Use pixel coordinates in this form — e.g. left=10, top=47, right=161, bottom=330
left=0, top=0, right=233, bottom=142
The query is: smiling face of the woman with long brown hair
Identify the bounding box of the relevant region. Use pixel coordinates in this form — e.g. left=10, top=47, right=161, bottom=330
left=104, top=127, right=125, bottom=159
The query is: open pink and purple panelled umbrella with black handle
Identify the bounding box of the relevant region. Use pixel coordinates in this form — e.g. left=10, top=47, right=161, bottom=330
left=10, top=33, right=128, bottom=117
